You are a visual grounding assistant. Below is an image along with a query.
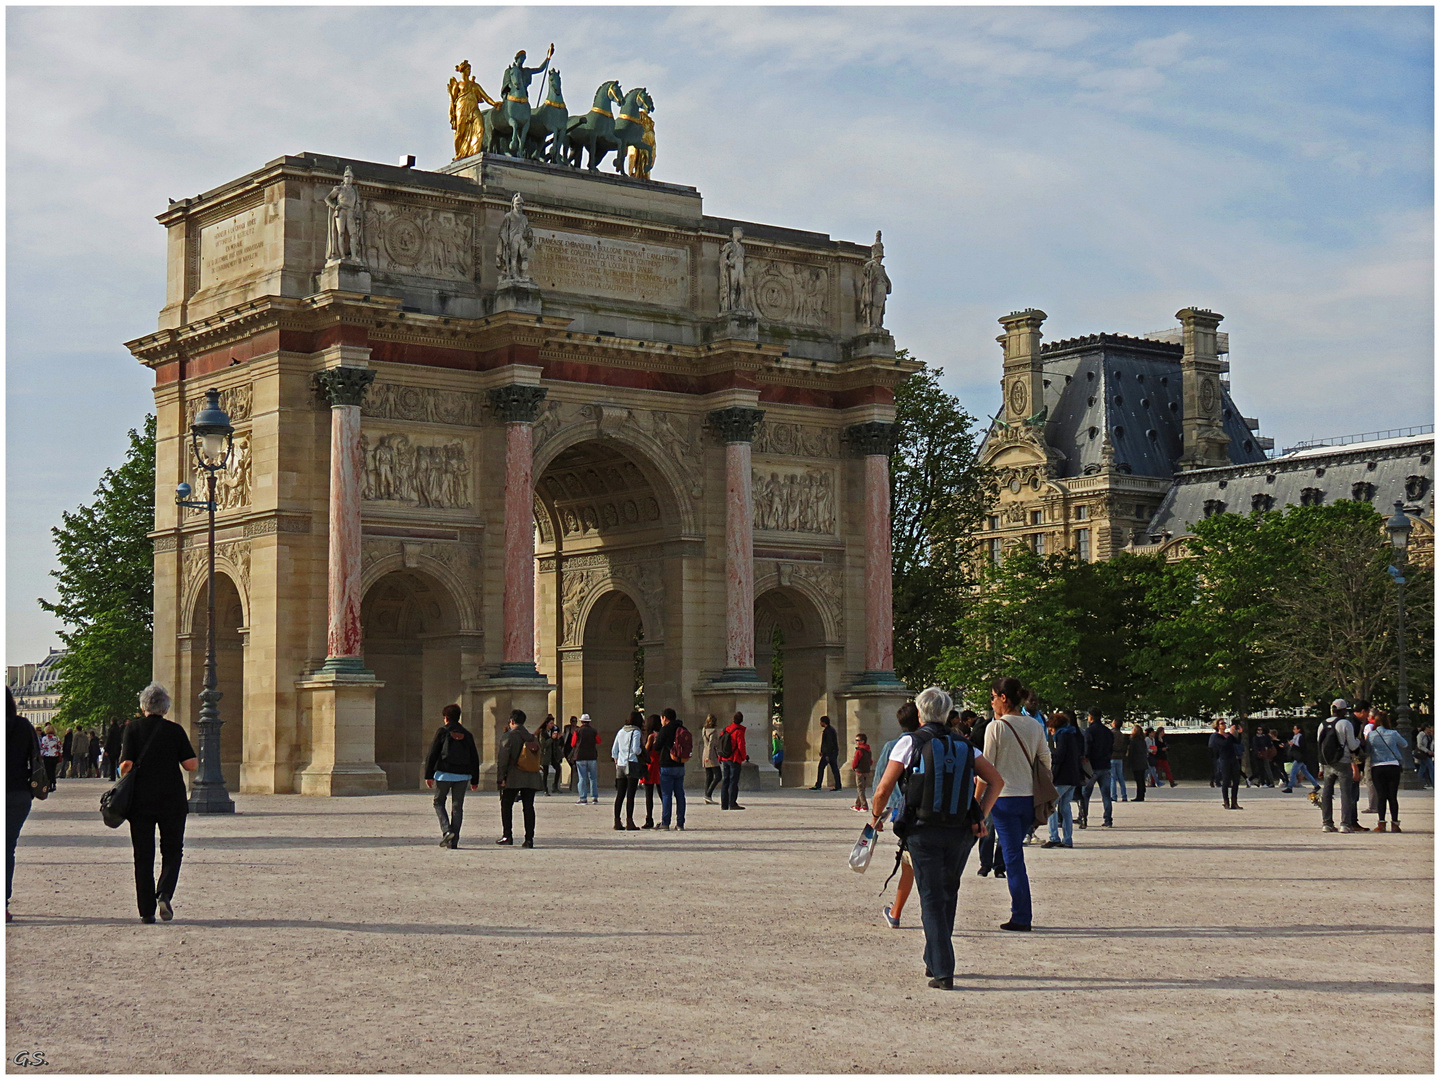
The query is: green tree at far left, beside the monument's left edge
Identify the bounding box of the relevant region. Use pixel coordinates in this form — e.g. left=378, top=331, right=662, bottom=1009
left=39, top=416, right=156, bottom=727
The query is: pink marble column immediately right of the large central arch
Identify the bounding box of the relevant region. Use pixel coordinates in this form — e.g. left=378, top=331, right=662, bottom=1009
left=710, top=408, right=765, bottom=680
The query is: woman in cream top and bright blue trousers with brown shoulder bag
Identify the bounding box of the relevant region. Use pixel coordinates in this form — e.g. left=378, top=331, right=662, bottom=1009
left=979, top=677, right=1048, bottom=930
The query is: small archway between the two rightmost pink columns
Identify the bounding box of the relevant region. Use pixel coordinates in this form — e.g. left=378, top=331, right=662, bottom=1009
left=750, top=586, right=845, bottom=786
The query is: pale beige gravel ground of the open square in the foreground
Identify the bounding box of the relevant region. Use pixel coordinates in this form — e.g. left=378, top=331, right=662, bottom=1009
left=6, top=780, right=1434, bottom=1073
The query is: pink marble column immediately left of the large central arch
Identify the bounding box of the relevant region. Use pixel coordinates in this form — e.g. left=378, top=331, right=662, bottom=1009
left=490, top=384, right=547, bottom=678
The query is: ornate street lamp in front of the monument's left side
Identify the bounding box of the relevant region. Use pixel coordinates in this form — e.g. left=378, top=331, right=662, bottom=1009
left=176, top=389, right=235, bottom=814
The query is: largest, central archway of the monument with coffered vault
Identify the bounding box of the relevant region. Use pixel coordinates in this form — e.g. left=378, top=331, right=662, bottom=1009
left=534, top=438, right=684, bottom=732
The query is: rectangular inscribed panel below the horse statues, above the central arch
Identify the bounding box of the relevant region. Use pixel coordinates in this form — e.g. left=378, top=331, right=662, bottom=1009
left=530, top=229, right=690, bottom=308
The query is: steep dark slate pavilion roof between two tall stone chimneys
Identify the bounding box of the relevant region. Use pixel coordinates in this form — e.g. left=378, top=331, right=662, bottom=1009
left=1040, top=334, right=1266, bottom=480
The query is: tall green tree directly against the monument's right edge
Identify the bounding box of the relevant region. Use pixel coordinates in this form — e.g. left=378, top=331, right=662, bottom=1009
left=890, top=360, right=995, bottom=688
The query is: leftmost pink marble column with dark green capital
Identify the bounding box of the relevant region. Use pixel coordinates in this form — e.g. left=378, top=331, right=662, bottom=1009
left=315, top=367, right=374, bottom=671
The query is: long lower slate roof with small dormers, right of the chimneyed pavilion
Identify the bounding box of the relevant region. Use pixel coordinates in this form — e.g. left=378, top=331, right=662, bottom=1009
left=1146, top=435, right=1436, bottom=543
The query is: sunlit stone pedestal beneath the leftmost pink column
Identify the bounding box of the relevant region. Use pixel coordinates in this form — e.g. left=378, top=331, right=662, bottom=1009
left=295, top=671, right=389, bottom=795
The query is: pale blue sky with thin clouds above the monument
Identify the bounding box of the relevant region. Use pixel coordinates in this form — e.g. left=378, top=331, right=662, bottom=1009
left=6, top=7, right=1434, bottom=664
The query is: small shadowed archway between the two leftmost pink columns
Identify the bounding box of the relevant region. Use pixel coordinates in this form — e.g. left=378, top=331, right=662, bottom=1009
left=360, top=569, right=464, bottom=791
